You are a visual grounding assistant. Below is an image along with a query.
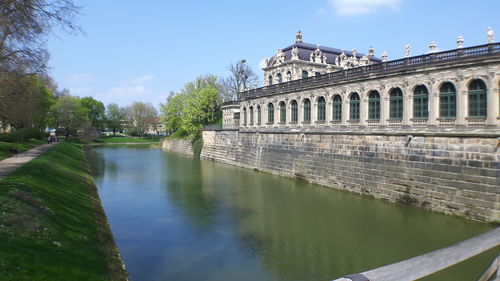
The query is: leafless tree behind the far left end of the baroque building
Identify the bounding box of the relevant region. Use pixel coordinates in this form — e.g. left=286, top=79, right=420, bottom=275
left=222, top=60, right=259, bottom=100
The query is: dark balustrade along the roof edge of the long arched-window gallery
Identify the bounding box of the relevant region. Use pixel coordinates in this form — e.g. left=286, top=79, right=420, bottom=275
left=240, top=43, right=500, bottom=100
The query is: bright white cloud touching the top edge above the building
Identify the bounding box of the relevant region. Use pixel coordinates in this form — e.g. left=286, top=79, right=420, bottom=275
left=329, top=0, right=402, bottom=15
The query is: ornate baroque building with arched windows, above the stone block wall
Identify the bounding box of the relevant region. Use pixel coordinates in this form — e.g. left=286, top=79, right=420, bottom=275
left=223, top=32, right=500, bottom=131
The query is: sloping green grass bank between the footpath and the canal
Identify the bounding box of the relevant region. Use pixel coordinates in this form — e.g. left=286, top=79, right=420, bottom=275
left=0, top=143, right=126, bottom=281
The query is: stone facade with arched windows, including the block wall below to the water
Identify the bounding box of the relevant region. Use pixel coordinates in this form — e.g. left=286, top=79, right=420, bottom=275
left=192, top=33, right=500, bottom=222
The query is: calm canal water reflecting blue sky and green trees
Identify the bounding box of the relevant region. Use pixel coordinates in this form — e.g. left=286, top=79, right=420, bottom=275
left=87, top=146, right=498, bottom=281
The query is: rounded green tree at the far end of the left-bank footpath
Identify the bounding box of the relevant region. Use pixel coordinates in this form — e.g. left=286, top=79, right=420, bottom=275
left=50, top=96, right=90, bottom=139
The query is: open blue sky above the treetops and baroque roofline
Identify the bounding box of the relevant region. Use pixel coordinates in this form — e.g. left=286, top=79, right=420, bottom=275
left=49, top=0, right=500, bottom=106
